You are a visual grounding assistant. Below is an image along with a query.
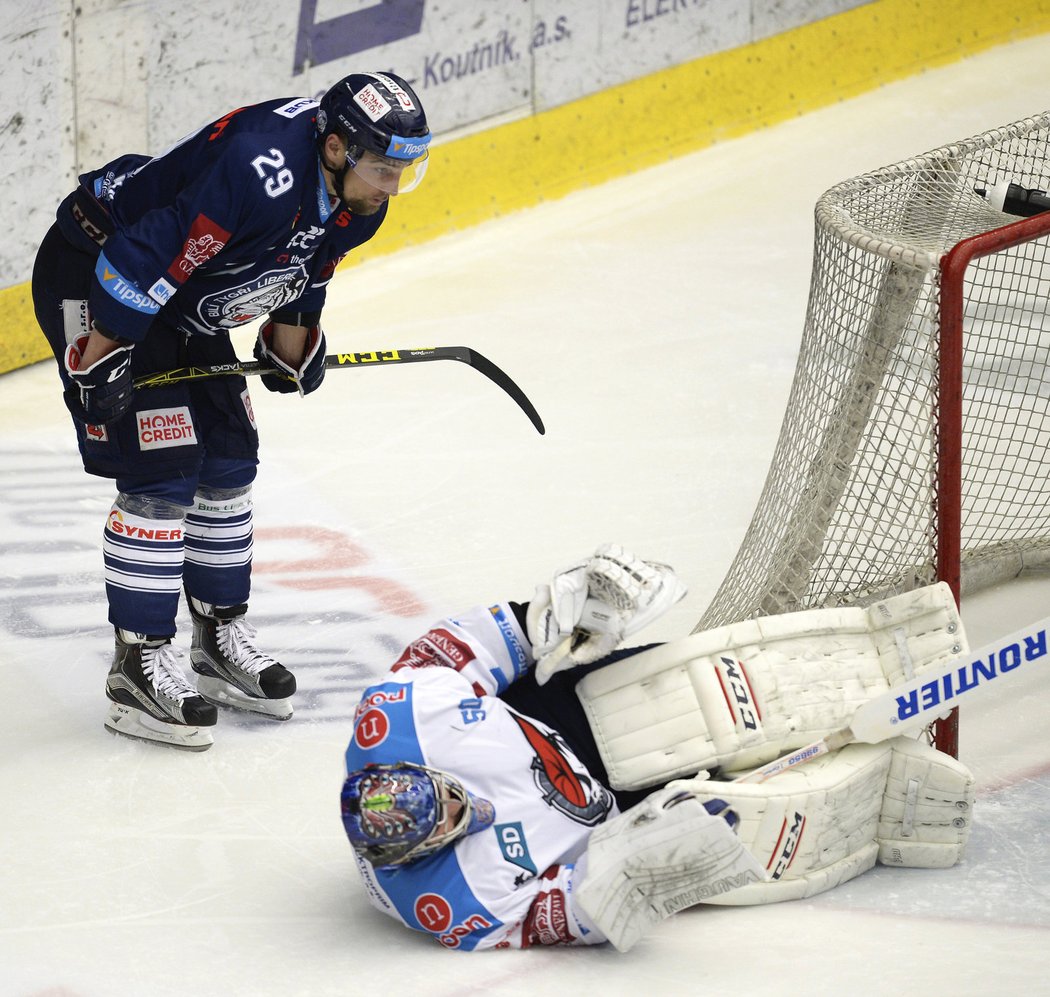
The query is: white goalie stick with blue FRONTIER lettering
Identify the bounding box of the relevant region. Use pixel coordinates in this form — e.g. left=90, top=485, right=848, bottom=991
left=735, top=617, right=1050, bottom=782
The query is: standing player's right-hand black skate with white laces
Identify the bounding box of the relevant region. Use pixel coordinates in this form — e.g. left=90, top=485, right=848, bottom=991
left=188, top=596, right=295, bottom=720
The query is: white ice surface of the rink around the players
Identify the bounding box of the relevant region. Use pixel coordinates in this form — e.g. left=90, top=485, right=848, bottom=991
left=0, top=38, right=1050, bottom=997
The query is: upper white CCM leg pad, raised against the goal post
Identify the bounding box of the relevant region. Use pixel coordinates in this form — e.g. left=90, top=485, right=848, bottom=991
left=576, top=582, right=968, bottom=789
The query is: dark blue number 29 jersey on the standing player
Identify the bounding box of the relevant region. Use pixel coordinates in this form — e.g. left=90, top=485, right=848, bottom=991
left=80, top=98, right=386, bottom=342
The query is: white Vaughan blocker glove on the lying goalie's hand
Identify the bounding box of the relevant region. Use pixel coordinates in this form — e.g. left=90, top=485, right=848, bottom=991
left=572, top=785, right=762, bottom=952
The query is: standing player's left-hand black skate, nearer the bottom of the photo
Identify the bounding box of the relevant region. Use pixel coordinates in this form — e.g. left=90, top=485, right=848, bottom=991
left=105, top=629, right=218, bottom=751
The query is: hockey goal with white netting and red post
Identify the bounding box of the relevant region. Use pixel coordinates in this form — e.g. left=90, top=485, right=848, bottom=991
left=696, top=112, right=1050, bottom=751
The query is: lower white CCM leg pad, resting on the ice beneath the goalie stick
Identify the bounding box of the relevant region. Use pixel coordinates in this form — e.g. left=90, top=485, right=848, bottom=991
left=693, top=738, right=973, bottom=905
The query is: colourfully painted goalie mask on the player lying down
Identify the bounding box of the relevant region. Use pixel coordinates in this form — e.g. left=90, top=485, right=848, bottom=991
left=342, top=762, right=496, bottom=869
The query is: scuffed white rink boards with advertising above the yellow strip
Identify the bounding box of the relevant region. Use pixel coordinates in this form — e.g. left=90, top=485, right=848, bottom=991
left=0, top=0, right=865, bottom=288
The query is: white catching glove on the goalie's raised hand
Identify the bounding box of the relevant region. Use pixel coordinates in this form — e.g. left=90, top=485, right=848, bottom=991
left=526, top=544, right=686, bottom=685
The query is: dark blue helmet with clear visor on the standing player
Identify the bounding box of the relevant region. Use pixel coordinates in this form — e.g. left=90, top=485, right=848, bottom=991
left=316, top=72, right=431, bottom=194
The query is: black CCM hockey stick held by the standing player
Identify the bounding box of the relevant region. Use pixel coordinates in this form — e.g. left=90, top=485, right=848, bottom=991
left=134, top=346, right=546, bottom=436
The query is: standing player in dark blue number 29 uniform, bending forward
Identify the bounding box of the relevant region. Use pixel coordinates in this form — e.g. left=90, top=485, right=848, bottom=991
left=33, top=72, right=431, bottom=750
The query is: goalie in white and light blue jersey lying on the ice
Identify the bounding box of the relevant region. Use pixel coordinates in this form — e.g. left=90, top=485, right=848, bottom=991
left=342, top=545, right=973, bottom=951
